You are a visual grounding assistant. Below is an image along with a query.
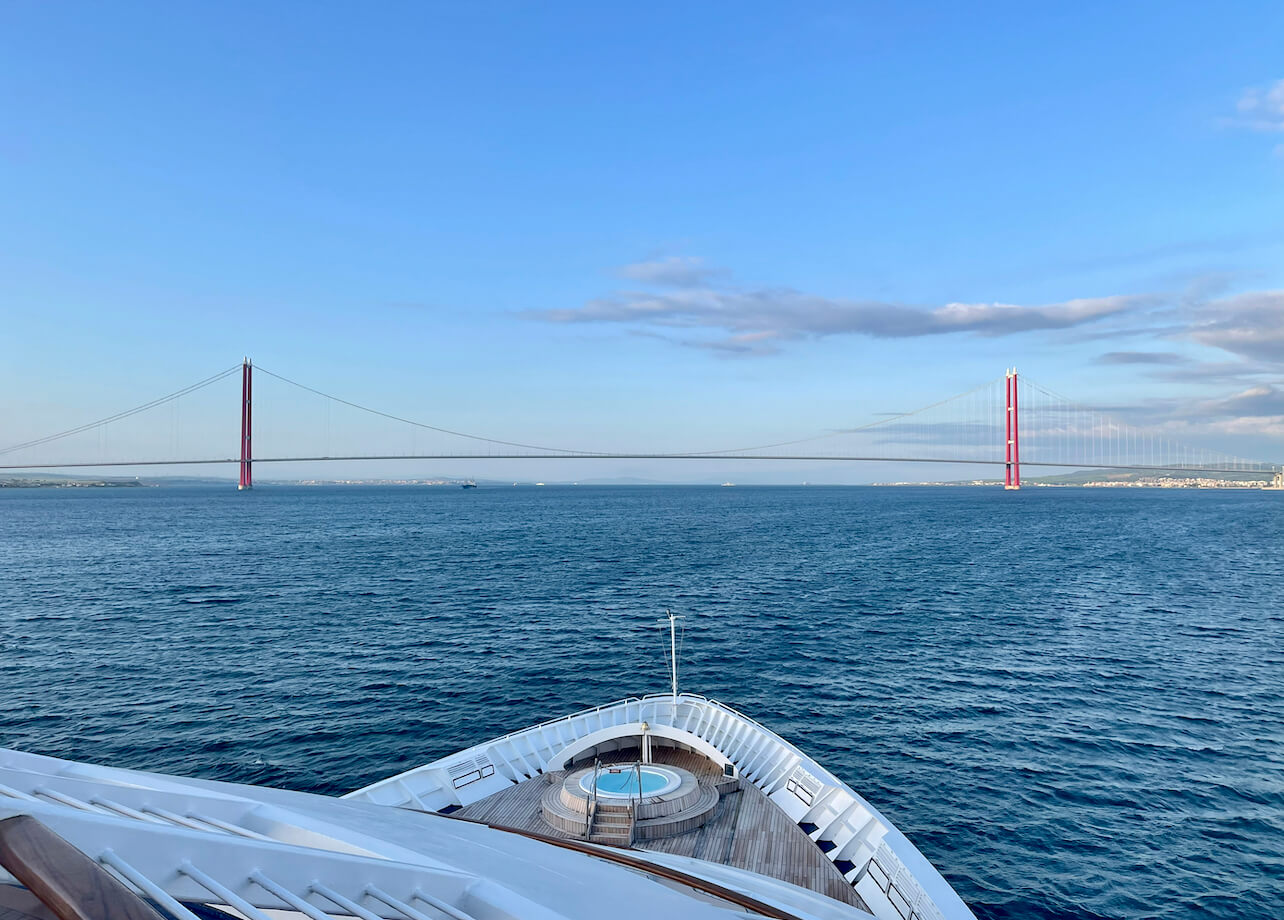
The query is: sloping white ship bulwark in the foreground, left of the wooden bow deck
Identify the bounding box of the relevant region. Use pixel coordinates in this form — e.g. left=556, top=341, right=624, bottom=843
left=0, top=749, right=878, bottom=920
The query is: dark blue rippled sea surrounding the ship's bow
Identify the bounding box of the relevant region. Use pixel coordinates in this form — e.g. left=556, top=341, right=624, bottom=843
left=0, top=484, right=1284, bottom=920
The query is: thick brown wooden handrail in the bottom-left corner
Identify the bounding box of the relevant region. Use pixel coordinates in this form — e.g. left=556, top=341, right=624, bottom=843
left=0, top=815, right=164, bottom=920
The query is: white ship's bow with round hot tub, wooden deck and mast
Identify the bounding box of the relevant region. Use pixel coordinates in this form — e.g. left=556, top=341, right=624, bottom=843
left=0, top=615, right=975, bottom=920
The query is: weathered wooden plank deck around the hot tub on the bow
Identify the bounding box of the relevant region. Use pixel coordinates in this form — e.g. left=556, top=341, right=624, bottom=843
left=455, top=747, right=869, bottom=912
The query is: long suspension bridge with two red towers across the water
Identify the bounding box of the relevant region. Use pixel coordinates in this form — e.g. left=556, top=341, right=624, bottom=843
left=0, top=358, right=1284, bottom=489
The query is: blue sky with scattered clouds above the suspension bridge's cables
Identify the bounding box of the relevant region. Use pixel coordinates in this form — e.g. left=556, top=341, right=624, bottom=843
left=0, top=3, right=1284, bottom=481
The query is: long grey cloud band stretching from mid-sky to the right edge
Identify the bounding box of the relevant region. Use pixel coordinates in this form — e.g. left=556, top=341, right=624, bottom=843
left=523, top=257, right=1284, bottom=374
